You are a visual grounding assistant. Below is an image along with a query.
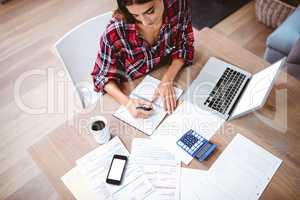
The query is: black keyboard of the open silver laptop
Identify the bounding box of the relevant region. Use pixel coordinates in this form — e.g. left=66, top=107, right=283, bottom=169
left=204, top=68, right=246, bottom=114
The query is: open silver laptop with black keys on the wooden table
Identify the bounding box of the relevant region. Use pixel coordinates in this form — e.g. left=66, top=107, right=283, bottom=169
left=183, top=57, right=286, bottom=120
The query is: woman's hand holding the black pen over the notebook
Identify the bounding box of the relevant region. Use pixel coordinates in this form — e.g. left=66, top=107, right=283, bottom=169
left=126, top=99, right=153, bottom=119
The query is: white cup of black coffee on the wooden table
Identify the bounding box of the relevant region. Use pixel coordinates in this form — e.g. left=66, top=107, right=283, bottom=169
left=88, top=116, right=110, bottom=144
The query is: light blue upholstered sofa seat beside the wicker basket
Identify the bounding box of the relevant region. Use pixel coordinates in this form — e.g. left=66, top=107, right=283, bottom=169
left=264, top=6, right=300, bottom=63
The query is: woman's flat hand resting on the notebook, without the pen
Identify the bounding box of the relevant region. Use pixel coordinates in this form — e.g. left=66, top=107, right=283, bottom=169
left=152, top=80, right=176, bottom=114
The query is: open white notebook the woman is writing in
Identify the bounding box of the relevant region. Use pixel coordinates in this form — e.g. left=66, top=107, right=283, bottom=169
left=113, top=75, right=183, bottom=135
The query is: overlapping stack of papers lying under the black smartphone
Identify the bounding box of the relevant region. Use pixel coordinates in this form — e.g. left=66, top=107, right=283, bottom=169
left=62, top=137, right=153, bottom=200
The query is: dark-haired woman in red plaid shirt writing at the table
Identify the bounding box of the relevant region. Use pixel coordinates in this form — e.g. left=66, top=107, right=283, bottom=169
left=92, top=0, right=194, bottom=118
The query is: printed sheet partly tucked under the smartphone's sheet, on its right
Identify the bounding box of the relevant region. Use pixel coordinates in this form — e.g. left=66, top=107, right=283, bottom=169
left=131, top=138, right=181, bottom=200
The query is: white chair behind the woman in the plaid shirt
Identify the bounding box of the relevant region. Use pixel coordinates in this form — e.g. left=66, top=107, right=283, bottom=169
left=55, top=12, right=112, bottom=108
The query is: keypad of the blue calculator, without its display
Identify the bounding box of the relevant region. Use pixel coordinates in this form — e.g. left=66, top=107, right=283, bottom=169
left=177, top=130, right=207, bottom=156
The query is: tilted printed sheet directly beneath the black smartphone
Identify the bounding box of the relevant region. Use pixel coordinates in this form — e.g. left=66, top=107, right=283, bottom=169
left=76, top=137, right=153, bottom=200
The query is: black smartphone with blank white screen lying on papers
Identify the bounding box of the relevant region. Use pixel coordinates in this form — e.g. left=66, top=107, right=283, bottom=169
left=106, top=155, right=128, bottom=185
